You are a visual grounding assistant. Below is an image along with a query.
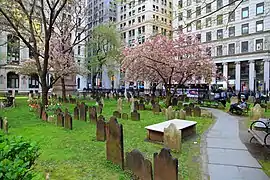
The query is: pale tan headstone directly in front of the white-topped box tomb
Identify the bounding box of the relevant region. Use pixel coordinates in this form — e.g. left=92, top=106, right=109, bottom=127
left=163, top=123, right=181, bottom=152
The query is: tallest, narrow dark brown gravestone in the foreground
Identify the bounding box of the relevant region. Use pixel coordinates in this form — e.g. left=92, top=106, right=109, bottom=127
left=106, top=117, right=124, bottom=169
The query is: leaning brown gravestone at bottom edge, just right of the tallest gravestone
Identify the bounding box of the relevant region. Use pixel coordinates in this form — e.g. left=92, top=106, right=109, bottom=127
left=126, top=149, right=153, bottom=180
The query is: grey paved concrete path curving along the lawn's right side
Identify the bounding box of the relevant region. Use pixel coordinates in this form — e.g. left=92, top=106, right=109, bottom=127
left=204, top=109, right=270, bottom=180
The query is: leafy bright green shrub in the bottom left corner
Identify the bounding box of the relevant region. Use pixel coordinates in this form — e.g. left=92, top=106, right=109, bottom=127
left=0, top=135, right=39, bottom=180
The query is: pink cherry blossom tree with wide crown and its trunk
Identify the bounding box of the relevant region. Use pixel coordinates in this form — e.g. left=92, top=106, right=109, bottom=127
left=122, top=33, right=215, bottom=106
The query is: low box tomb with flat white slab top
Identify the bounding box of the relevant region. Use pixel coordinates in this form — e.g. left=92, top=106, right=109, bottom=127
left=145, top=119, right=197, bottom=142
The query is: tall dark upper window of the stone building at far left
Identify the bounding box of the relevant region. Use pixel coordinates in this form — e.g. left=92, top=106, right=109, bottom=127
left=7, top=34, right=20, bottom=63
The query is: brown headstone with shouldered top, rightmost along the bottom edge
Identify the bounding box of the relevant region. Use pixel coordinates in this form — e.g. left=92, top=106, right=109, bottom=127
left=154, top=148, right=178, bottom=180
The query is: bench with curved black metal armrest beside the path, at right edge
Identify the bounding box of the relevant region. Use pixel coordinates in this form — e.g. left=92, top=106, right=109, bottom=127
left=248, top=120, right=270, bottom=147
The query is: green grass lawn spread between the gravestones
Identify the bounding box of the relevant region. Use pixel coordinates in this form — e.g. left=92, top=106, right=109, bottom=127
left=0, top=99, right=213, bottom=180
